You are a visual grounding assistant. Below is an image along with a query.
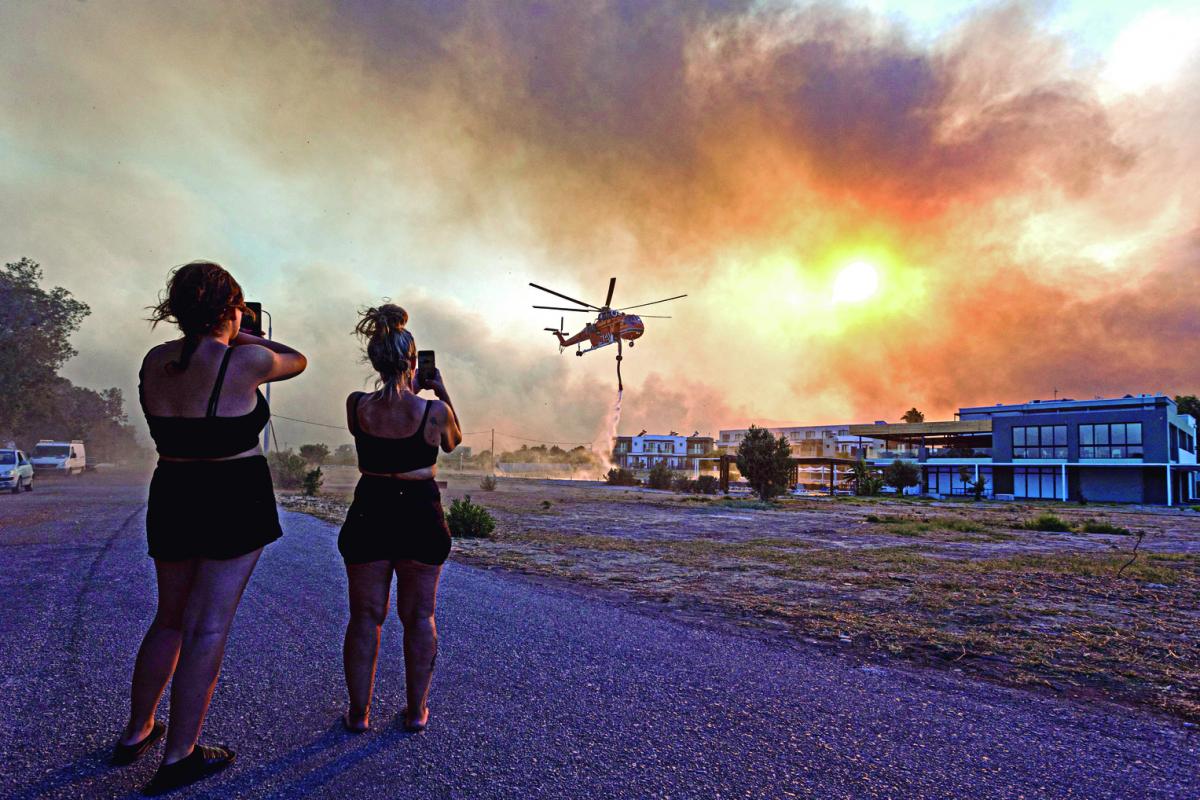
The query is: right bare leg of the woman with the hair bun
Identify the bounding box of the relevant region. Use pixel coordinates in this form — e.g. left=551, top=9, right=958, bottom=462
left=396, top=560, right=442, bottom=726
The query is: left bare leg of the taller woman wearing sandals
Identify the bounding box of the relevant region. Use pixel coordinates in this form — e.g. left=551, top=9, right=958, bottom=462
left=120, top=559, right=199, bottom=745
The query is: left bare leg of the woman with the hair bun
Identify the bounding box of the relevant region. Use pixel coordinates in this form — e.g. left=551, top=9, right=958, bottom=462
left=342, top=561, right=391, bottom=730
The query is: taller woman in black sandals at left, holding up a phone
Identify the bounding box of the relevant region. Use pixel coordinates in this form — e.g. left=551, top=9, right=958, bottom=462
left=113, top=261, right=306, bottom=793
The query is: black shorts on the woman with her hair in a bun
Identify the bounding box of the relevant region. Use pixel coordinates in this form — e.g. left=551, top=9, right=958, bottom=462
left=337, top=475, right=450, bottom=566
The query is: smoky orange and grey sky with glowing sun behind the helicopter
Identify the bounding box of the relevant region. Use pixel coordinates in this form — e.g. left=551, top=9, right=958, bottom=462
left=0, top=0, right=1200, bottom=449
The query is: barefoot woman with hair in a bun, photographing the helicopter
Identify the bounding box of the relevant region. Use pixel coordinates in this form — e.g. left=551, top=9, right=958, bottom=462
left=337, top=303, right=462, bottom=732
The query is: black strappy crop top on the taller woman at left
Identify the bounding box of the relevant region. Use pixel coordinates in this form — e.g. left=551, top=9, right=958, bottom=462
left=138, top=348, right=271, bottom=458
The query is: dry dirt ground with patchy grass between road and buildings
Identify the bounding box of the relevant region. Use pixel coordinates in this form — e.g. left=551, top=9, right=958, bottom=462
left=281, top=468, right=1200, bottom=721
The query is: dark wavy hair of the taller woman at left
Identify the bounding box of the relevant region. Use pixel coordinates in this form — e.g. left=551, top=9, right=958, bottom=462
left=150, top=261, right=251, bottom=372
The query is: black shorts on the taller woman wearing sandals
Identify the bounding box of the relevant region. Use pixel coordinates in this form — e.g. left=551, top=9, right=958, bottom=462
left=146, top=456, right=283, bottom=561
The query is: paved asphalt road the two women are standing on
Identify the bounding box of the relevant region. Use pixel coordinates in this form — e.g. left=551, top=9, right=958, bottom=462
left=0, top=476, right=1200, bottom=800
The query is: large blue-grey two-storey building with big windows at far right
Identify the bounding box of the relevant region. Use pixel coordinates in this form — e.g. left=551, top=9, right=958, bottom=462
left=850, top=395, right=1198, bottom=505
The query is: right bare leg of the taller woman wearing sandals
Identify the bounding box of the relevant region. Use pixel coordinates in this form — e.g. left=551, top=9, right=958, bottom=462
left=163, top=547, right=263, bottom=764
